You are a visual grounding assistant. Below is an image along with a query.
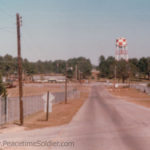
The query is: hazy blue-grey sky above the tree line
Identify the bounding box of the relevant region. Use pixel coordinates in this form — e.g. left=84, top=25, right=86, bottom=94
left=0, top=0, right=150, bottom=65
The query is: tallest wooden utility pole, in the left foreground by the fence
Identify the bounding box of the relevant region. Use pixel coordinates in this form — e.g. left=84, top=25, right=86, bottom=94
left=16, top=13, right=23, bottom=125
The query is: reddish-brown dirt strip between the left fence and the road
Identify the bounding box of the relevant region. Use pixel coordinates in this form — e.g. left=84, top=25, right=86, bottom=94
left=24, top=86, right=90, bottom=130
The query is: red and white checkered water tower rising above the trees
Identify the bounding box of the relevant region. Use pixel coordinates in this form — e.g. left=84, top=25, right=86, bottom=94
left=115, top=38, right=128, bottom=61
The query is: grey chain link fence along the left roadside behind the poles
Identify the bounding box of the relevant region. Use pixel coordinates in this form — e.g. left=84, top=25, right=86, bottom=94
left=0, top=89, right=80, bottom=125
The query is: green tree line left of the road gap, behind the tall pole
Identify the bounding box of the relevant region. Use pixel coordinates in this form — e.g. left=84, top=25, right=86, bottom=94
left=0, top=55, right=92, bottom=78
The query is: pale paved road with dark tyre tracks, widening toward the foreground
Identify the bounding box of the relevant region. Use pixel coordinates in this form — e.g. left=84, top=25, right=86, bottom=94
left=0, top=86, right=150, bottom=150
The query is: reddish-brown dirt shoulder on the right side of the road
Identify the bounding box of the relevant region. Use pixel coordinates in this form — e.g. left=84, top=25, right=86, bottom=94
left=108, top=87, right=150, bottom=108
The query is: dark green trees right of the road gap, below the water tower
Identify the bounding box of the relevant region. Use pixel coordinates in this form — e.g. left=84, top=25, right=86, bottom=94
left=98, top=56, right=150, bottom=82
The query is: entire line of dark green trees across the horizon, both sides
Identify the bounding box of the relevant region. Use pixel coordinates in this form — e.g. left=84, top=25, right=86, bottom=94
left=0, top=55, right=150, bottom=82
